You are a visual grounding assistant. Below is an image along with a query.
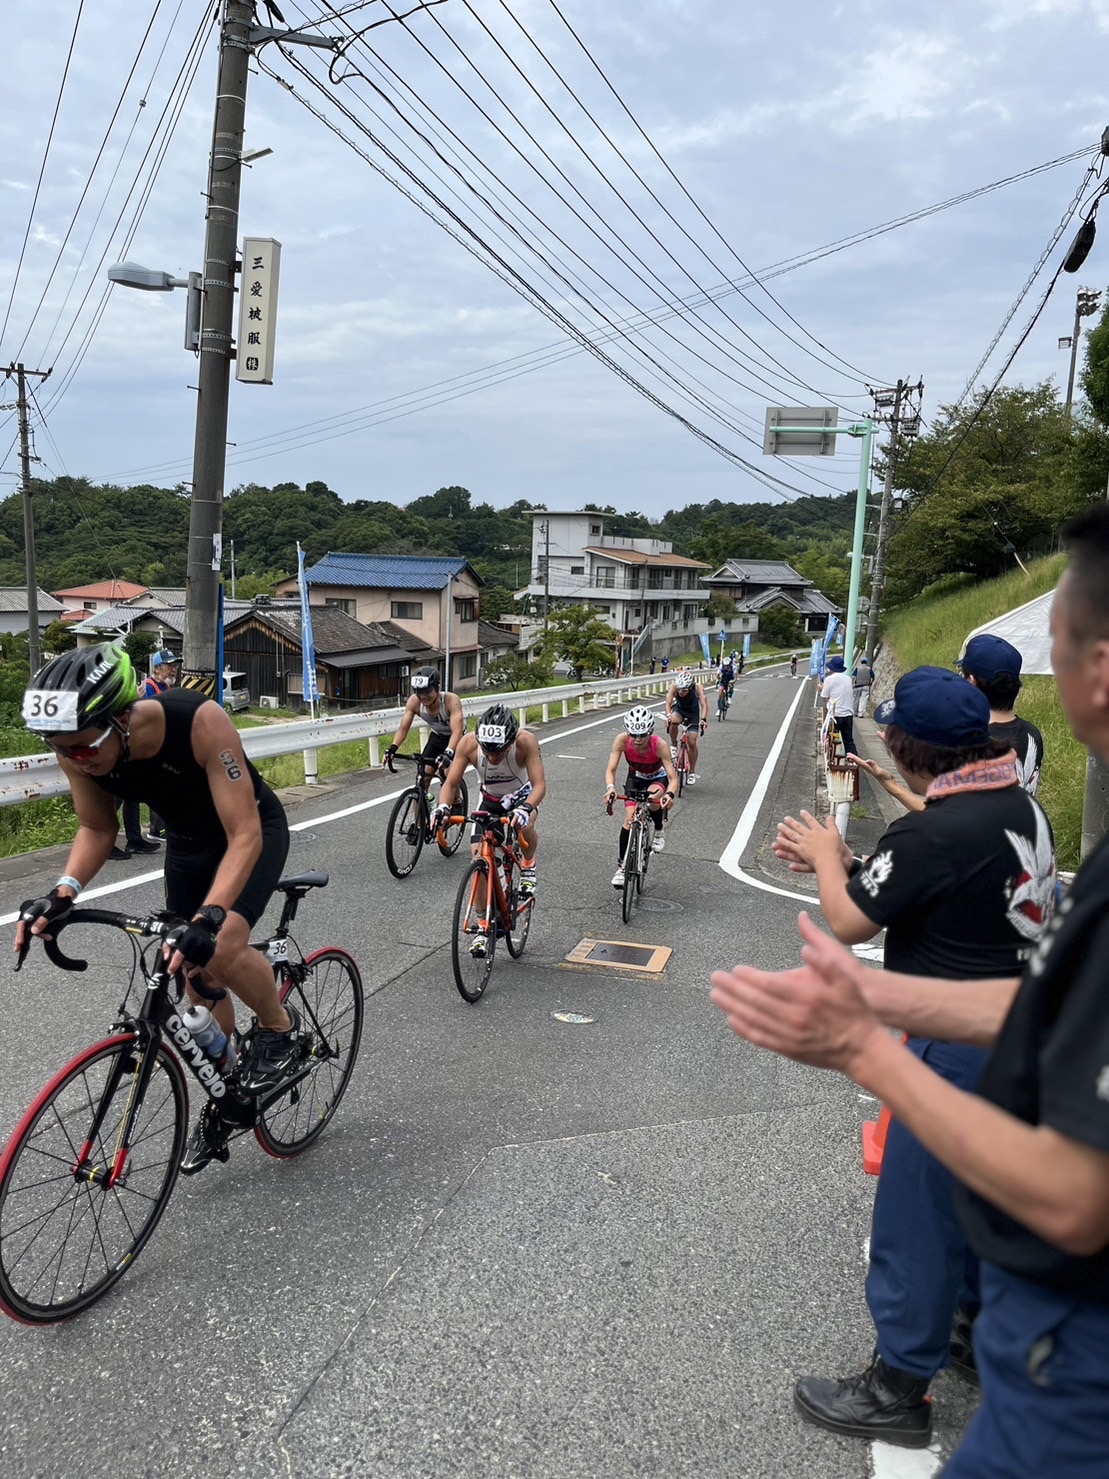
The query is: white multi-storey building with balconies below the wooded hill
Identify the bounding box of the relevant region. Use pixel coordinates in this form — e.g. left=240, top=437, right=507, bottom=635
left=518, top=509, right=710, bottom=663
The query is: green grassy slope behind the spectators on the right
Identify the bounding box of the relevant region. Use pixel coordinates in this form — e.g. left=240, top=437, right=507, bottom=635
left=883, top=555, right=1085, bottom=870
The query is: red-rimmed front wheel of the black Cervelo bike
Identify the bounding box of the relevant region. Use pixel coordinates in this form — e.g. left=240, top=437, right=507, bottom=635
left=0, top=1032, right=189, bottom=1325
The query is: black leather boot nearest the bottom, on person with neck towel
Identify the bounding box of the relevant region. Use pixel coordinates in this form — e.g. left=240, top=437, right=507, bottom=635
left=793, top=1355, right=932, bottom=1448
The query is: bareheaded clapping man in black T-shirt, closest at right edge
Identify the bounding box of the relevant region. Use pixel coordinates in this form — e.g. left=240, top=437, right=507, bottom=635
left=713, top=504, right=1109, bottom=1479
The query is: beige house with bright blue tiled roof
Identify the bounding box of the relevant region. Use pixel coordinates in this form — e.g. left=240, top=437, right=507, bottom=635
left=277, top=552, right=484, bottom=691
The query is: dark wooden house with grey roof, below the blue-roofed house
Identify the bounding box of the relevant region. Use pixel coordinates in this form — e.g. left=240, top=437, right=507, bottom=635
left=223, top=602, right=438, bottom=711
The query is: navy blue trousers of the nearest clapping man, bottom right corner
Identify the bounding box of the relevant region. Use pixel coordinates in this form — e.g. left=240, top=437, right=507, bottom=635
left=940, top=1266, right=1109, bottom=1479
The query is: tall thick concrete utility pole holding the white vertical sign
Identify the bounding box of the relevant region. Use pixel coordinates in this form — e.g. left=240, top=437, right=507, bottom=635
left=180, top=0, right=254, bottom=698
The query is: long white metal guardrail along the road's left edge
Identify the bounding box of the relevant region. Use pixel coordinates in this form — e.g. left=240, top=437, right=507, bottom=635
left=0, top=670, right=711, bottom=806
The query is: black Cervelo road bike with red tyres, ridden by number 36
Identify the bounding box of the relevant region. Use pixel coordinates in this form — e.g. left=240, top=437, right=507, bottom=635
left=0, top=873, right=362, bottom=1325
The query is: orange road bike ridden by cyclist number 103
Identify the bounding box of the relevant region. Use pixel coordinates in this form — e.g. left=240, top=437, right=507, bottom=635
left=451, top=810, right=535, bottom=1001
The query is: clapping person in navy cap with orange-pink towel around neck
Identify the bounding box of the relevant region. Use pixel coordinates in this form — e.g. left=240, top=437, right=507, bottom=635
left=773, top=667, right=1054, bottom=1448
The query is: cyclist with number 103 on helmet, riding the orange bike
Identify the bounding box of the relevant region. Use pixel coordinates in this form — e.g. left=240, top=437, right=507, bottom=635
left=432, top=704, right=547, bottom=893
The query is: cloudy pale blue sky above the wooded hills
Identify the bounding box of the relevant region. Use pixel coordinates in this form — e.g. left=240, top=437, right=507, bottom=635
left=0, top=0, right=1109, bottom=516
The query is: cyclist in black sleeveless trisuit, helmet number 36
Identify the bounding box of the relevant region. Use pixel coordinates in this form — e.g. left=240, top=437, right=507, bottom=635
left=16, top=643, right=300, bottom=1170
